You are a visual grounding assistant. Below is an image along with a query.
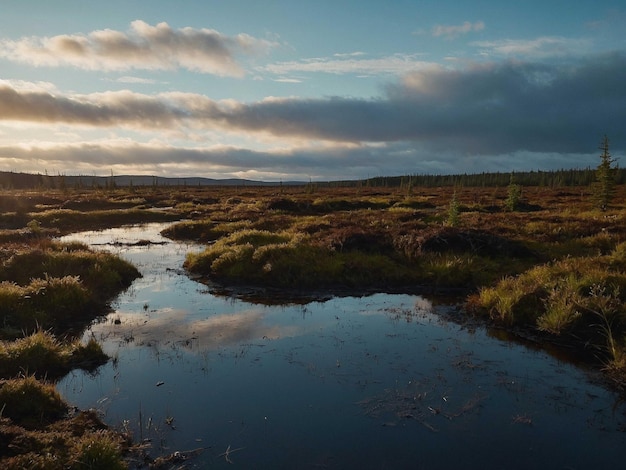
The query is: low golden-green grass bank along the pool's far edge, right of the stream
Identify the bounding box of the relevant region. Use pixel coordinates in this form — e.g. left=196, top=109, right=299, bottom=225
left=185, top=226, right=520, bottom=292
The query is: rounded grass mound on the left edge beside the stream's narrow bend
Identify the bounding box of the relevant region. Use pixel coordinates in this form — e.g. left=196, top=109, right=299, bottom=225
left=0, top=239, right=139, bottom=338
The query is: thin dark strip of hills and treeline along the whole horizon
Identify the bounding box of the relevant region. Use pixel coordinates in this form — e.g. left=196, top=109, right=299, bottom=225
left=0, top=168, right=626, bottom=189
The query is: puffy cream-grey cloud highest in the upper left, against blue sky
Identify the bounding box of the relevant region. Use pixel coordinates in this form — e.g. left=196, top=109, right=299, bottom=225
left=0, top=20, right=276, bottom=77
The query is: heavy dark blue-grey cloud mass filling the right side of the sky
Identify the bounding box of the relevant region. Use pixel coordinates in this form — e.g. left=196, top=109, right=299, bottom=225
left=220, top=53, right=626, bottom=154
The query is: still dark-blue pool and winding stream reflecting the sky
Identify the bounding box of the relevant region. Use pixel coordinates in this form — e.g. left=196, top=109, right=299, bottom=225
left=58, top=224, right=626, bottom=469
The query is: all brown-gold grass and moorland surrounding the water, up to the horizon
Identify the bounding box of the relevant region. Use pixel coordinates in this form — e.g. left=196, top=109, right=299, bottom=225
left=0, top=185, right=626, bottom=462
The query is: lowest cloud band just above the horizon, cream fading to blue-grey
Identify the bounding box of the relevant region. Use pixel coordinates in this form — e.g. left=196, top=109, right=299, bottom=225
left=0, top=141, right=598, bottom=181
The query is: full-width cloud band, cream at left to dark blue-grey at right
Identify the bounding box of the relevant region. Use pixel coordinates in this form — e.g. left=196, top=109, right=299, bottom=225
left=0, top=52, right=626, bottom=155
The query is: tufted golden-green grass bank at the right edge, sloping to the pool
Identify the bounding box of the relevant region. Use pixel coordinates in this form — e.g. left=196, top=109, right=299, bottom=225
left=468, top=242, right=626, bottom=380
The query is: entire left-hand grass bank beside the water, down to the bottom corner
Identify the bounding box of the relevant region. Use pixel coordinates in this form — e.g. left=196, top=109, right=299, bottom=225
left=0, top=230, right=139, bottom=469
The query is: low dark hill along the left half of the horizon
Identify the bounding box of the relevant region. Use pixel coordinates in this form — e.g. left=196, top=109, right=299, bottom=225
left=0, top=171, right=305, bottom=189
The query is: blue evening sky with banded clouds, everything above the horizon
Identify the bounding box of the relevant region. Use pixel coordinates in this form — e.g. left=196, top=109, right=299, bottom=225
left=0, top=0, right=626, bottom=182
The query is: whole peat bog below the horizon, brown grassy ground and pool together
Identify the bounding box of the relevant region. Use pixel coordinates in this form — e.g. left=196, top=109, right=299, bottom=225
left=0, top=185, right=626, bottom=468
